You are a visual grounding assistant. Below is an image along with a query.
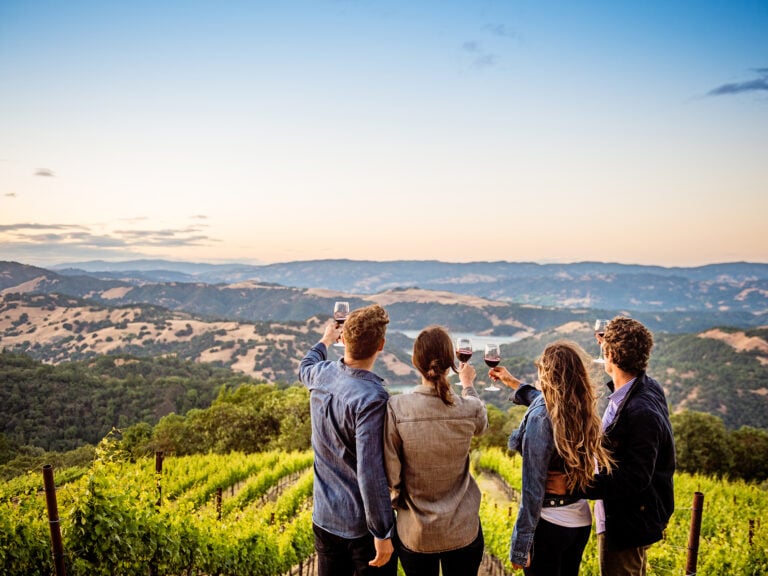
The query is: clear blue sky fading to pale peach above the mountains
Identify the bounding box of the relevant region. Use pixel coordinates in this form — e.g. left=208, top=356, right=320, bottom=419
left=0, top=0, right=768, bottom=267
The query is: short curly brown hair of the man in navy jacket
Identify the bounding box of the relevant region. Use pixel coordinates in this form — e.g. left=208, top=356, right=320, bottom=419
left=603, top=316, right=653, bottom=376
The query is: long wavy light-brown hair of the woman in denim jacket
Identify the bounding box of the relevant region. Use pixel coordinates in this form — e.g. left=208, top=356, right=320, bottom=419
left=536, top=340, right=614, bottom=492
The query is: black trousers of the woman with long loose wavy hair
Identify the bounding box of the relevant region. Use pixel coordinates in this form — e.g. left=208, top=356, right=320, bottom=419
left=523, top=518, right=592, bottom=576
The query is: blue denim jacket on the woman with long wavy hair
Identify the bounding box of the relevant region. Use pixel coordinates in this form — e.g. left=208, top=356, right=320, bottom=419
left=508, top=384, right=555, bottom=566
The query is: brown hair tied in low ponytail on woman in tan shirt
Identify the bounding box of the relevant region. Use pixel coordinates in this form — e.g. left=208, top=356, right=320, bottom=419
left=413, top=326, right=458, bottom=406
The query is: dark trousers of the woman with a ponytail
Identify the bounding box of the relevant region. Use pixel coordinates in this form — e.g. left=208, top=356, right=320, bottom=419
left=394, top=526, right=485, bottom=576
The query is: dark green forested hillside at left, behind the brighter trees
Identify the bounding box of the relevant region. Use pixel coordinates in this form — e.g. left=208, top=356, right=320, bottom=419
left=0, top=352, right=253, bottom=451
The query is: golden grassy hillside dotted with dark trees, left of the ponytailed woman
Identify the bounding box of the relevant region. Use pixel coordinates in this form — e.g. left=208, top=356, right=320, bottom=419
left=0, top=294, right=420, bottom=383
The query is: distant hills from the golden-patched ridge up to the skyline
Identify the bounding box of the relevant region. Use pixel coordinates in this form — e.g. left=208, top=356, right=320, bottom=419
left=0, top=260, right=768, bottom=335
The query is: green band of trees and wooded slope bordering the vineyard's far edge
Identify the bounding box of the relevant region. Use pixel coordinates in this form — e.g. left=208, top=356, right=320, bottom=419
left=0, top=353, right=768, bottom=482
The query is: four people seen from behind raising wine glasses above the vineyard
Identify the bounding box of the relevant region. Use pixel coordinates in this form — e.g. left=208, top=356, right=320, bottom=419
left=300, top=304, right=675, bottom=576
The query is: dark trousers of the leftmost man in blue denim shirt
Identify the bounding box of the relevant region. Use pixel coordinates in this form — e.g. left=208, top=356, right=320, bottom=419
left=312, top=524, right=397, bottom=576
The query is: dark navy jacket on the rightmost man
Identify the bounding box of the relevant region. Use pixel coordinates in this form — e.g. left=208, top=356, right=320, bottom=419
left=584, top=373, right=675, bottom=550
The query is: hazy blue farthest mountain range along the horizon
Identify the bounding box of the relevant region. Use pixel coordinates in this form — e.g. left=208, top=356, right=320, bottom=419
left=46, top=260, right=768, bottom=313
